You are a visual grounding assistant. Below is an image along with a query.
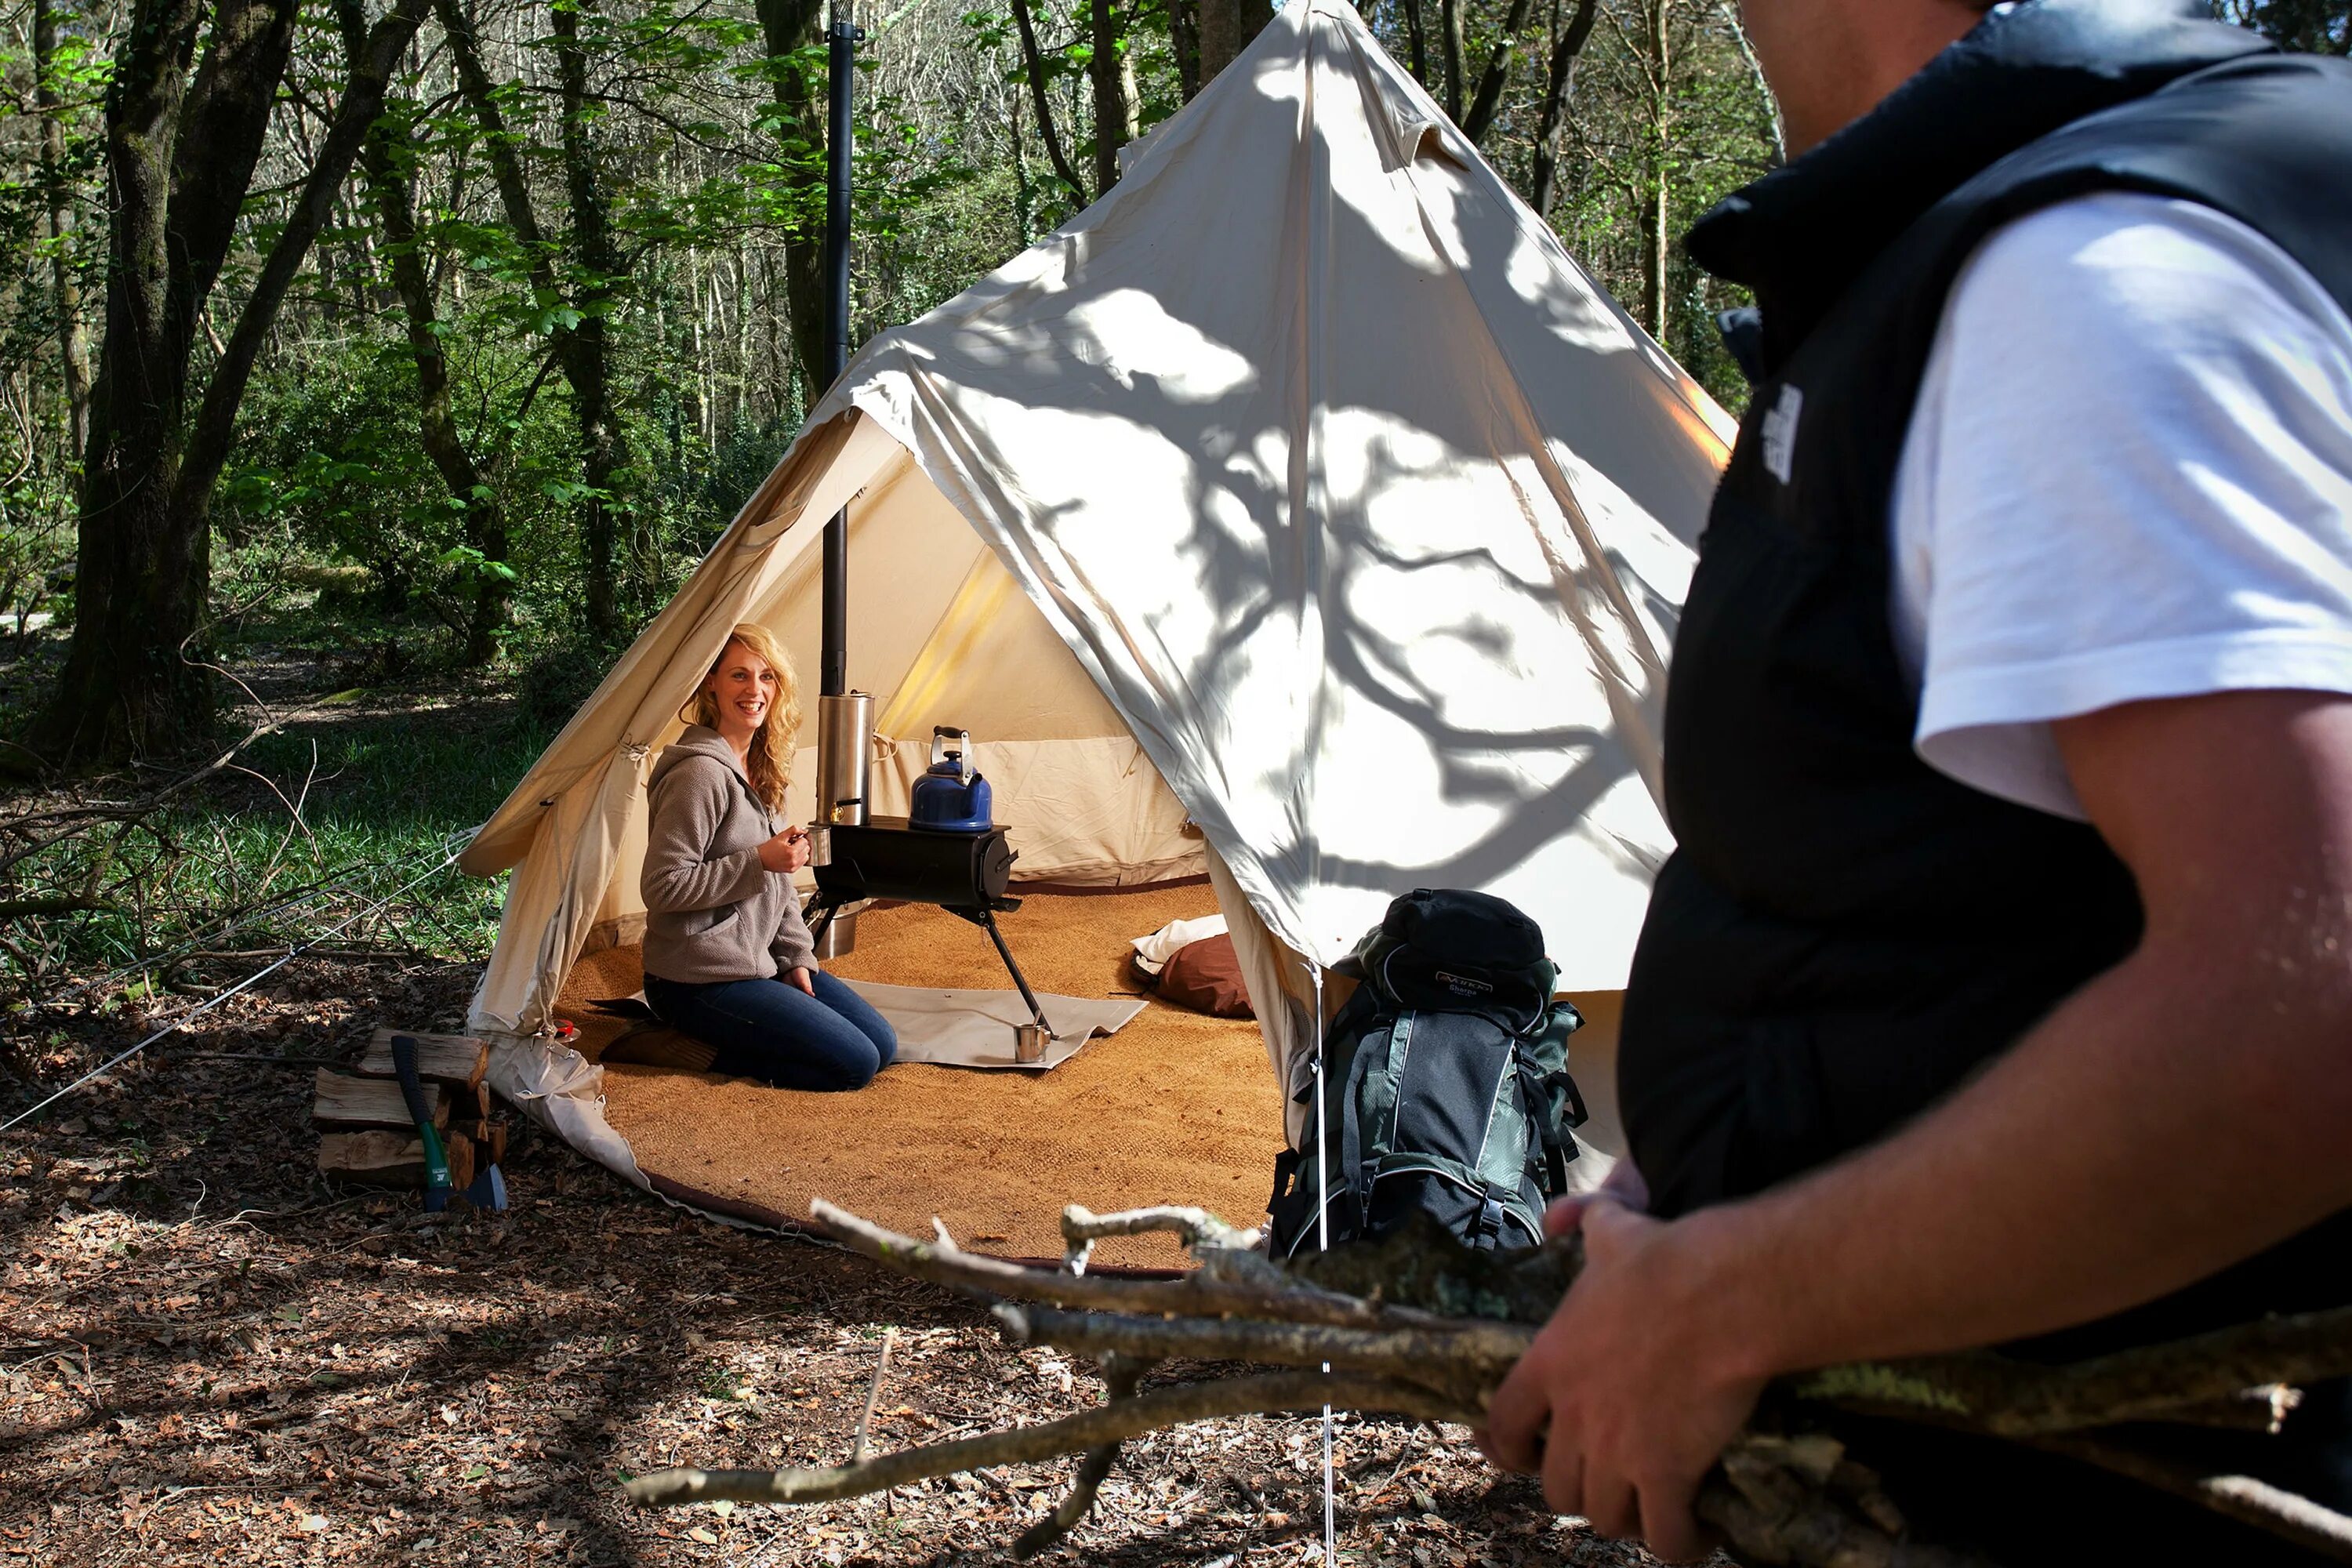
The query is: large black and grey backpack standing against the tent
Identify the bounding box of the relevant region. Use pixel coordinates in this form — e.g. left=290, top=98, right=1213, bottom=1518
left=1268, top=888, right=1585, bottom=1258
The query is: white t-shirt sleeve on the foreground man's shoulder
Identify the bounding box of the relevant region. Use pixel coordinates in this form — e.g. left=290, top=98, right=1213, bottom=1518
left=1891, top=193, right=2352, bottom=818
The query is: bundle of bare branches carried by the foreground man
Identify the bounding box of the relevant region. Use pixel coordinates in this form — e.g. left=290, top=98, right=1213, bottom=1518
left=628, top=1201, right=2352, bottom=1568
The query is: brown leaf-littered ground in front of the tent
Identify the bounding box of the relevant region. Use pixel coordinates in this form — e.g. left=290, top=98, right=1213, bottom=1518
left=0, top=961, right=1693, bottom=1568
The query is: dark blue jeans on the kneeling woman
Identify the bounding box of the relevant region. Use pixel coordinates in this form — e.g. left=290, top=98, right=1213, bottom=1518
left=644, top=973, right=898, bottom=1088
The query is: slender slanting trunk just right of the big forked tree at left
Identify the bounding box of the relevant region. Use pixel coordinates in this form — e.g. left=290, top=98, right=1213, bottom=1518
left=336, top=0, right=508, bottom=668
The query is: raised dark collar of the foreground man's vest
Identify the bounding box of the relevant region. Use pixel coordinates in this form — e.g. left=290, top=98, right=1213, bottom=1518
left=1689, top=0, right=2272, bottom=369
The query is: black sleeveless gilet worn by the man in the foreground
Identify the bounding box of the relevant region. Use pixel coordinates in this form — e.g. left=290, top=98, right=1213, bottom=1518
left=1618, top=0, right=2352, bottom=1213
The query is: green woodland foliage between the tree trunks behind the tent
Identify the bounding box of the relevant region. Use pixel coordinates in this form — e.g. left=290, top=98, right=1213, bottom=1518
left=41, top=0, right=2314, bottom=766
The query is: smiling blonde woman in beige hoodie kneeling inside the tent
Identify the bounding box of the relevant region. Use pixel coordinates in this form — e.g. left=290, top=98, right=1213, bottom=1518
left=640, top=626, right=898, bottom=1088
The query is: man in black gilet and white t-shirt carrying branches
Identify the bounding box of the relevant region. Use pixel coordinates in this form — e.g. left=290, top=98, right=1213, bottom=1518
left=1484, top=0, right=2352, bottom=1561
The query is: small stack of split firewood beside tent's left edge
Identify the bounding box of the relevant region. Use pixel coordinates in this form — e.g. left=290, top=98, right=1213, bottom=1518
left=310, top=1027, right=506, bottom=1192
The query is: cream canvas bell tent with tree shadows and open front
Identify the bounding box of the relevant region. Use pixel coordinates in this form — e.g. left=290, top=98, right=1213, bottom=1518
left=463, top=0, right=1731, bottom=1203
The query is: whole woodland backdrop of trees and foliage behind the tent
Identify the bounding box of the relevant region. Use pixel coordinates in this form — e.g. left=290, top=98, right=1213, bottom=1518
left=0, top=0, right=2352, bottom=769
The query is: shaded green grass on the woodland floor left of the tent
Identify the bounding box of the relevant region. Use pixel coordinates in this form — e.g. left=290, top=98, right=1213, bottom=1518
left=0, top=604, right=644, bottom=1011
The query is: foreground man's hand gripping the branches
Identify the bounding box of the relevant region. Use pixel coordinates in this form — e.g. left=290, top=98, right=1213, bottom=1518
left=1479, top=1194, right=1764, bottom=1559
